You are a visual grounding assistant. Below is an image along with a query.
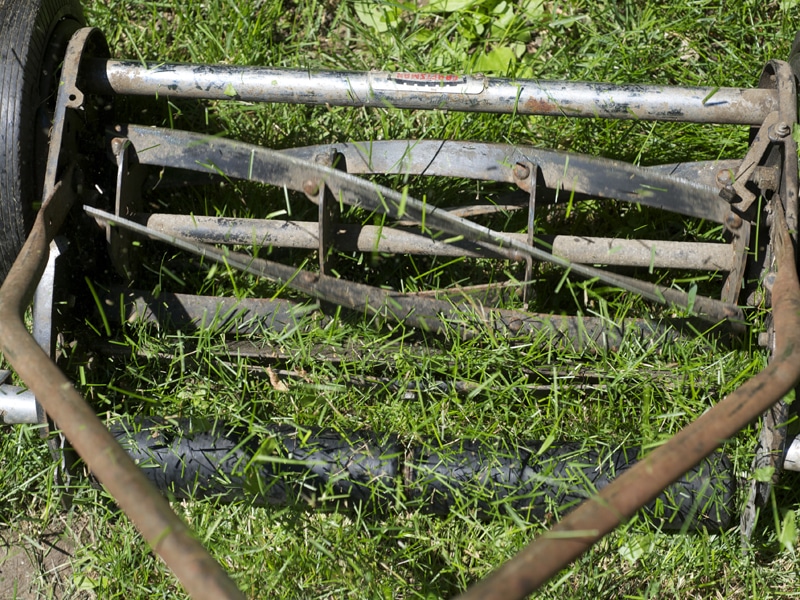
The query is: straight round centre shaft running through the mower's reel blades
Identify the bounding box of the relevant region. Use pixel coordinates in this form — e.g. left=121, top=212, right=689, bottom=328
left=136, top=213, right=734, bottom=272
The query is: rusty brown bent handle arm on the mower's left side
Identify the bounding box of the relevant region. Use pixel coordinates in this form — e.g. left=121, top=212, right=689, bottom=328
left=0, top=180, right=244, bottom=600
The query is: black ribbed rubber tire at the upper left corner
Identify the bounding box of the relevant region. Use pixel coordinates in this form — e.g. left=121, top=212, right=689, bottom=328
left=0, top=0, right=84, bottom=282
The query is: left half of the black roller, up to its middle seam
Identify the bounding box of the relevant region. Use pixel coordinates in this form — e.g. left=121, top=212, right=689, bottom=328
left=111, top=418, right=401, bottom=507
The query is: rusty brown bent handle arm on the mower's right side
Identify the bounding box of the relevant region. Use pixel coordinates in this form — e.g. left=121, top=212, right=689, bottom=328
left=460, top=197, right=800, bottom=600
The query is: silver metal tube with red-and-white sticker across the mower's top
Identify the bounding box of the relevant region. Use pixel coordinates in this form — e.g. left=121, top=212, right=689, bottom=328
left=82, top=59, right=778, bottom=125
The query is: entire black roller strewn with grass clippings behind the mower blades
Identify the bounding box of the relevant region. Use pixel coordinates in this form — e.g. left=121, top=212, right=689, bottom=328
left=112, top=419, right=735, bottom=531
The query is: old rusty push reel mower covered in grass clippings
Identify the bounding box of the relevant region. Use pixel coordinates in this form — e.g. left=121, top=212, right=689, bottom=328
left=0, top=0, right=800, bottom=598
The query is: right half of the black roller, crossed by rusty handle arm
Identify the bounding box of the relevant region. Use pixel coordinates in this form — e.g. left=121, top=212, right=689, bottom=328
left=407, top=441, right=735, bottom=530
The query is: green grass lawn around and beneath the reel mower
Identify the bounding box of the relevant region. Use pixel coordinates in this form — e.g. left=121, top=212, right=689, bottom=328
left=0, top=0, right=800, bottom=598
